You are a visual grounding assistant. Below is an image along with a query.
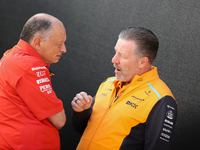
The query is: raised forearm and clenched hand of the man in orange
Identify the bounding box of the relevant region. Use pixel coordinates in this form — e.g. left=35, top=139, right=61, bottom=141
left=71, top=92, right=93, bottom=134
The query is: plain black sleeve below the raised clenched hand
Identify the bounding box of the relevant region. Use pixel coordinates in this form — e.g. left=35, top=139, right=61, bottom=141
left=72, top=97, right=95, bottom=134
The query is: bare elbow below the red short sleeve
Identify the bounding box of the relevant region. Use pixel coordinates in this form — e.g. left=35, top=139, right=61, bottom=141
left=47, top=109, right=66, bottom=130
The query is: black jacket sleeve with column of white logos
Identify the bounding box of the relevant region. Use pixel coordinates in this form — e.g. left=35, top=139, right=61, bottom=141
left=144, top=96, right=178, bottom=150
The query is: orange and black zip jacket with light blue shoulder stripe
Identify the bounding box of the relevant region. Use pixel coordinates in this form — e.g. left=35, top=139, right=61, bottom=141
left=73, top=67, right=177, bottom=150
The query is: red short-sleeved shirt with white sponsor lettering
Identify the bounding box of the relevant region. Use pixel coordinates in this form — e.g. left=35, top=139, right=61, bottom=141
left=0, top=40, right=63, bottom=150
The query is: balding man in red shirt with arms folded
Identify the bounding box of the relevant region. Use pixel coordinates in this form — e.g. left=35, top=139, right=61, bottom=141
left=0, top=13, right=66, bottom=150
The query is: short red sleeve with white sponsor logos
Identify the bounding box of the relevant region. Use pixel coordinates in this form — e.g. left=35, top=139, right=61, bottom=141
left=16, top=67, right=63, bottom=120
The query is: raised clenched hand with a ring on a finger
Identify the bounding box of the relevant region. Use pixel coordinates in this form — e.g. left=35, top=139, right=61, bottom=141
left=71, top=92, right=92, bottom=112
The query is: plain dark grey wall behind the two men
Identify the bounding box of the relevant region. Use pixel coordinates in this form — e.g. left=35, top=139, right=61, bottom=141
left=0, top=0, right=200, bottom=150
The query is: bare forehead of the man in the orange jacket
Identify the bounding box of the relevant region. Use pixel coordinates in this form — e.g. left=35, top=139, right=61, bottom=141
left=115, top=38, right=136, bottom=53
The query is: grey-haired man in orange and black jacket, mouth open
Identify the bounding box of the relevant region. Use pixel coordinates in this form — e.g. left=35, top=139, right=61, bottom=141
left=71, top=28, right=177, bottom=150
